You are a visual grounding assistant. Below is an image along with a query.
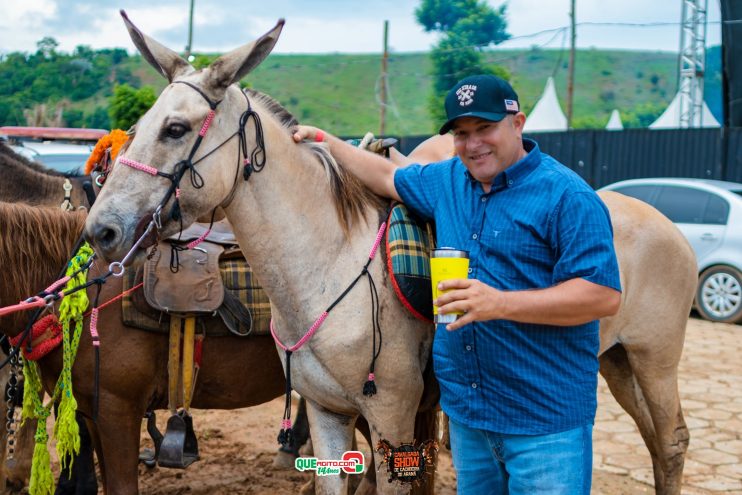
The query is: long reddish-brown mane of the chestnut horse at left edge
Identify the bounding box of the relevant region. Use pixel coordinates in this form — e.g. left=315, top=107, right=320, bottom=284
left=0, top=202, right=87, bottom=332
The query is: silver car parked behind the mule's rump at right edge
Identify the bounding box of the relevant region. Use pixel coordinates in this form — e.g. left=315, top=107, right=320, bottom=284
left=601, top=178, right=742, bottom=323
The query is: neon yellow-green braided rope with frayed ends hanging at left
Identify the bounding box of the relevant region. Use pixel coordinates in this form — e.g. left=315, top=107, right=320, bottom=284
left=21, top=243, right=93, bottom=495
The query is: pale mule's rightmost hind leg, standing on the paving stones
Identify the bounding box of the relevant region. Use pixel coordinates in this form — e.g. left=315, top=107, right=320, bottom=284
left=627, top=349, right=690, bottom=495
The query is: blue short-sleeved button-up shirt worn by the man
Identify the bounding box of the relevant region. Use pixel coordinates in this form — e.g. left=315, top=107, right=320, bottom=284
left=394, top=139, right=621, bottom=435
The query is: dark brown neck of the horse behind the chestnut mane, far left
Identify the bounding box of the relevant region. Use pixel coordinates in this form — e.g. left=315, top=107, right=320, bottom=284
left=0, top=160, right=65, bottom=206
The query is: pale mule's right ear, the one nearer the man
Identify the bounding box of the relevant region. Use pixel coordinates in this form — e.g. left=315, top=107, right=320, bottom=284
left=209, top=19, right=285, bottom=88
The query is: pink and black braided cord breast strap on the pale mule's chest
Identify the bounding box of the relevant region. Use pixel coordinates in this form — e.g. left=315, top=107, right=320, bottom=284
left=270, top=222, right=386, bottom=446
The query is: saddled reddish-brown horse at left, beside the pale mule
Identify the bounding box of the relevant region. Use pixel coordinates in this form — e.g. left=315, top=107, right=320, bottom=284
left=0, top=204, right=284, bottom=494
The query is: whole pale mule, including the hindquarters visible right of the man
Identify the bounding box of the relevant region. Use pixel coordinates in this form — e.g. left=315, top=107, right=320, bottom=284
left=86, top=12, right=697, bottom=494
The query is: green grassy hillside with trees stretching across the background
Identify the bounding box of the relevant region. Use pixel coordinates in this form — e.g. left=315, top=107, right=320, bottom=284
left=0, top=38, right=722, bottom=136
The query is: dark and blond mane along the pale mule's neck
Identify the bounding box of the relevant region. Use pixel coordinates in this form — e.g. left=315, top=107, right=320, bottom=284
left=245, top=89, right=384, bottom=237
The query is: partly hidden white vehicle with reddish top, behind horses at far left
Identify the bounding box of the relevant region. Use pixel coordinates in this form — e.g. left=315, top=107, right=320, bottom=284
left=0, top=126, right=107, bottom=174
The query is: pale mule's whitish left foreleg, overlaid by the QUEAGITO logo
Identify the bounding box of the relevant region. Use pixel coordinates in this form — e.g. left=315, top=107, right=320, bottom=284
left=307, top=399, right=356, bottom=495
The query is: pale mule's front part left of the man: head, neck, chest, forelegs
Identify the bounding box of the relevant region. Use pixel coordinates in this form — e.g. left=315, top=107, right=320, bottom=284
left=86, top=11, right=435, bottom=493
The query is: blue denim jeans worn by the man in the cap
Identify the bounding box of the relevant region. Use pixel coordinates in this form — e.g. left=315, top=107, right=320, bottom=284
left=449, top=420, right=593, bottom=495
